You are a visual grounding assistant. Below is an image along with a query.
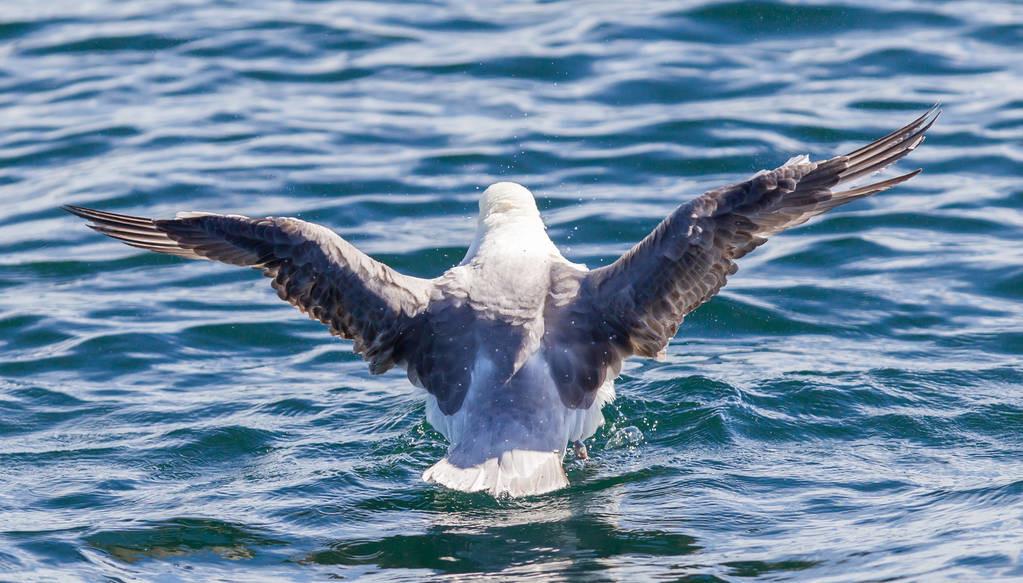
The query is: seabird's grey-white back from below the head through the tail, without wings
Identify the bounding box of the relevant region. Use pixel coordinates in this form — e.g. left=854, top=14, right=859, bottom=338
left=409, top=249, right=593, bottom=495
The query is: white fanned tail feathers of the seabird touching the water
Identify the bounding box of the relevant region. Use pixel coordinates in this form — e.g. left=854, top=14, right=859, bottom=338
left=422, top=449, right=569, bottom=497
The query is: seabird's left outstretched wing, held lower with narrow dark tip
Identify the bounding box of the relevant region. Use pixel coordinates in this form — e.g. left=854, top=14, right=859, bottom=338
left=64, top=207, right=432, bottom=373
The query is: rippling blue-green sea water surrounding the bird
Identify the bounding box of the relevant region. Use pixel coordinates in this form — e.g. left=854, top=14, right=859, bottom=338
left=0, top=0, right=1023, bottom=582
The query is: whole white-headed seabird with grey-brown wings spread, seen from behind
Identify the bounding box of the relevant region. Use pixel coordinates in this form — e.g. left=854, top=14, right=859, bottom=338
left=64, top=106, right=940, bottom=496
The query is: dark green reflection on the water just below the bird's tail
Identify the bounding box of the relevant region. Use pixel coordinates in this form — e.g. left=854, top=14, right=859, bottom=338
left=299, top=494, right=702, bottom=574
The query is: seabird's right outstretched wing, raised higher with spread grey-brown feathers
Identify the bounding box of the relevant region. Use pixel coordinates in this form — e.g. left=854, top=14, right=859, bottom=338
left=547, top=107, right=940, bottom=406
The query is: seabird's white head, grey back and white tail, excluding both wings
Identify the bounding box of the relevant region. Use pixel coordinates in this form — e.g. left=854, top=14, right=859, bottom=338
left=413, top=182, right=614, bottom=495
